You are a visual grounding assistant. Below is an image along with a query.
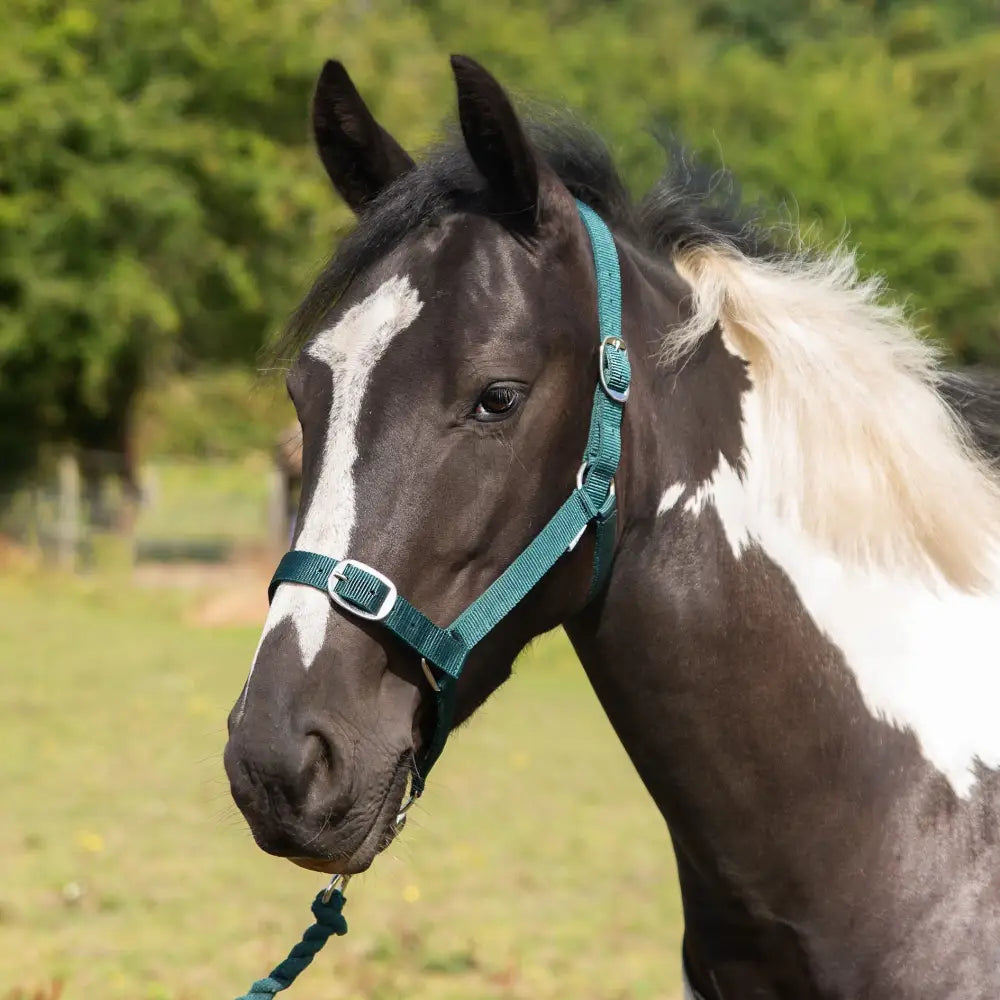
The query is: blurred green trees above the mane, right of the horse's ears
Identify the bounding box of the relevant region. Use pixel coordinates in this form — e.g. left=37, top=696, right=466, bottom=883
left=421, top=0, right=1000, bottom=362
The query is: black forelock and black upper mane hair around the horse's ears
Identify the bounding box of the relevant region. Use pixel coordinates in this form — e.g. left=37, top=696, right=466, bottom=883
left=274, top=112, right=777, bottom=363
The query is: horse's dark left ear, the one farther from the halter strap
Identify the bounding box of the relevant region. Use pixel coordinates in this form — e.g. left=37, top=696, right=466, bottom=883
left=312, top=60, right=413, bottom=212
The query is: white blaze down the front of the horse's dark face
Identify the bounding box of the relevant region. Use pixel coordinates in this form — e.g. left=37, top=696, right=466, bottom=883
left=254, top=276, right=422, bottom=684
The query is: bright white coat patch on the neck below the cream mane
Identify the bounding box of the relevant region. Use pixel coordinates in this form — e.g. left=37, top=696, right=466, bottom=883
left=684, top=382, right=1000, bottom=796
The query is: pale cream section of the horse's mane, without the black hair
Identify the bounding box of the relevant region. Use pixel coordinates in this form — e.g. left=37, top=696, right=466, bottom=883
left=663, top=245, right=1000, bottom=591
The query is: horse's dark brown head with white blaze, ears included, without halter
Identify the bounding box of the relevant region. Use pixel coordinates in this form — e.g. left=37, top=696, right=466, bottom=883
left=225, top=57, right=628, bottom=873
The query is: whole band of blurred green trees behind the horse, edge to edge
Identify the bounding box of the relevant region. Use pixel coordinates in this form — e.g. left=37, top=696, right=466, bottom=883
left=0, top=0, right=1000, bottom=484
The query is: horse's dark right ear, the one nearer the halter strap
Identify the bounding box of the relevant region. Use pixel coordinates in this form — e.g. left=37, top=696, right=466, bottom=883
left=451, top=56, right=538, bottom=232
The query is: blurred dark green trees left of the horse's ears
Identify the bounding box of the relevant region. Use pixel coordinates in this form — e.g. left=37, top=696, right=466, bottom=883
left=0, top=0, right=438, bottom=478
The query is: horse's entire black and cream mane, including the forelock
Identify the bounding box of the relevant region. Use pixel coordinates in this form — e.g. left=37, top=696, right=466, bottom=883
left=277, top=112, right=1000, bottom=590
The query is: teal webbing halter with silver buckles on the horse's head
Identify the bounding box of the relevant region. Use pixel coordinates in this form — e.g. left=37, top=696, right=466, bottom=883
left=268, top=201, right=632, bottom=796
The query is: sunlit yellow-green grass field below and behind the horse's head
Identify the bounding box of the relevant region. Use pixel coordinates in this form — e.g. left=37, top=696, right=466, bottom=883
left=0, top=575, right=680, bottom=1000
